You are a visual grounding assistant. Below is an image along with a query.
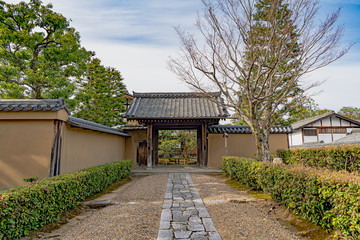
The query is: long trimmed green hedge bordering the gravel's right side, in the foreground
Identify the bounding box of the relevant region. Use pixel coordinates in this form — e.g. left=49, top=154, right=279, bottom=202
left=222, top=157, right=360, bottom=239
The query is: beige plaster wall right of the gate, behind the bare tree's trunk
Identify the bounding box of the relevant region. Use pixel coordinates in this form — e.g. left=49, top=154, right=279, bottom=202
left=208, top=134, right=288, bottom=168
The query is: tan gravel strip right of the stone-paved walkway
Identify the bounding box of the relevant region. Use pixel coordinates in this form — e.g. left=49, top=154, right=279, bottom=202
left=191, top=174, right=298, bottom=240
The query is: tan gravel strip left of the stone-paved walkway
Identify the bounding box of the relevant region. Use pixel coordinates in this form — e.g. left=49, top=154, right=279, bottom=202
left=38, top=174, right=168, bottom=240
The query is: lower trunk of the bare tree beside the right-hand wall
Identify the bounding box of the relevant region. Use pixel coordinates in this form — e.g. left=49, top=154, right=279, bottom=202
left=253, top=129, right=272, bottom=162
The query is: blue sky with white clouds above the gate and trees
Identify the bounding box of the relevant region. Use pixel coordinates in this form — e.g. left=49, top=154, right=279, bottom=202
left=5, top=0, right=360, bottom=111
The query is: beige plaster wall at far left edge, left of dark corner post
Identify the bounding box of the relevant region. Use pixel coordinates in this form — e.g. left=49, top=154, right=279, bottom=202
left=0, top=119, right=54, bottom=190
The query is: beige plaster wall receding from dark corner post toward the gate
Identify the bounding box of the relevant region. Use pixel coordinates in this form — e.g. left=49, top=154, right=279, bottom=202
left=60, top=123, right=126, bottom=174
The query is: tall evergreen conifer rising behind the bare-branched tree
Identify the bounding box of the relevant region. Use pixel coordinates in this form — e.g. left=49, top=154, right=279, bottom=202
left=242, top=0, right=304, bottom=159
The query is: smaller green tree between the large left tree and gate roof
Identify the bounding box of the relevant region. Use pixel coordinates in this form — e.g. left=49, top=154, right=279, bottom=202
left=74, top=58, right=126, bottom=126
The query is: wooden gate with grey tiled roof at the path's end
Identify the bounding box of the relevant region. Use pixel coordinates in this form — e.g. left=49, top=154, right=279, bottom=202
left=124, top=92, right=229, bottom=168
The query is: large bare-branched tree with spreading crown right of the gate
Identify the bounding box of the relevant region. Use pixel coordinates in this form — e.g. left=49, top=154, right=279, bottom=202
left=169, top=0, right=352, bottom=161
